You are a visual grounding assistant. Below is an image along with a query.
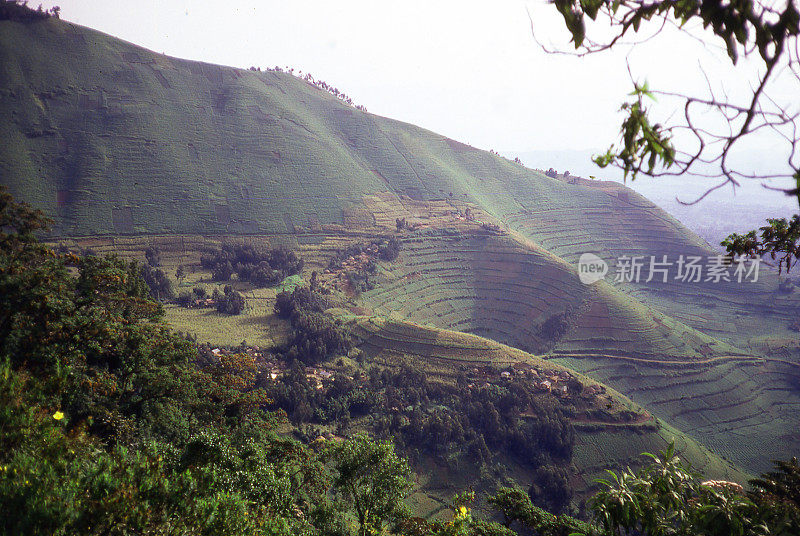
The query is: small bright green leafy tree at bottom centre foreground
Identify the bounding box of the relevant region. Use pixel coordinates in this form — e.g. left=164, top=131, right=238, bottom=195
left=329, top=434, right=411, bottom=536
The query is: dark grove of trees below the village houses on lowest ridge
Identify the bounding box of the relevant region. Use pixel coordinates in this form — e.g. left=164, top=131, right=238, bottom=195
left=268, top=366, right=574, bottom=511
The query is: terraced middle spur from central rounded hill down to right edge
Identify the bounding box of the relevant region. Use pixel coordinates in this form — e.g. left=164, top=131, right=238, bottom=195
left=362, top=237, right=800, bottom=471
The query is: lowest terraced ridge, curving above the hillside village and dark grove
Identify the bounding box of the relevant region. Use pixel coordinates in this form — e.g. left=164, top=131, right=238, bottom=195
left=350, top=317, right=748, bottom=495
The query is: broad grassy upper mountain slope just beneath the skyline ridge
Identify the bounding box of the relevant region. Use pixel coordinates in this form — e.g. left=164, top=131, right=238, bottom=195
left=0, top=16, right=797, bottom=347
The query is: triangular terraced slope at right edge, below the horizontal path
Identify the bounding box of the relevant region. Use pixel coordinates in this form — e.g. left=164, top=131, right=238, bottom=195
left=556, top=357, right=800, bottom=473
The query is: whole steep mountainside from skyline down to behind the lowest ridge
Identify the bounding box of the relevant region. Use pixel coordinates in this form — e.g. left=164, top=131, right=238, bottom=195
left=0, top=14, right=800, bottom=469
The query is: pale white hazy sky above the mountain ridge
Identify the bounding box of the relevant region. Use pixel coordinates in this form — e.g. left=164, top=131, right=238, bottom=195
left=32, top=0, right=800, bottom=205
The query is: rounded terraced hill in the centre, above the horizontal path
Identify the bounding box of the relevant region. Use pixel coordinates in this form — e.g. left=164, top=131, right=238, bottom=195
left=362, top=233, right=742, bottom=360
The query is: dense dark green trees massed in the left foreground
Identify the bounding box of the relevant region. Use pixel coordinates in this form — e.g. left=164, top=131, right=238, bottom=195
left=0, top=187, right=344, bottom=536
